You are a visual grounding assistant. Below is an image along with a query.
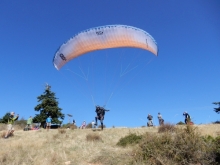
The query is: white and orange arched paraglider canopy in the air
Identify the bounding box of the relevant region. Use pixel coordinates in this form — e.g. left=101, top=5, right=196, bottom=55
left=53, top=25, right=158, bottom=70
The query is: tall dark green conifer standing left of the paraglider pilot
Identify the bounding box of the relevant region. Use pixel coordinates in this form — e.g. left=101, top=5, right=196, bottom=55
left=33, top=85, right=64, bottom=126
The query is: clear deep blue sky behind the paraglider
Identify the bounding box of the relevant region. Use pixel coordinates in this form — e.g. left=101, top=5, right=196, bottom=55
left=0, top=0, right=220, bottom=127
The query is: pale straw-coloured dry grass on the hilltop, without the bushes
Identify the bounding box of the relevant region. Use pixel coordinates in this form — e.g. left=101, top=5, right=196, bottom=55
left=0, top=124, right=220, bottom=165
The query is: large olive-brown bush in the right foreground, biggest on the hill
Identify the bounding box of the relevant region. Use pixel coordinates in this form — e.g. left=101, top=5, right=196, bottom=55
left=134, top=126, right=216, bottom=165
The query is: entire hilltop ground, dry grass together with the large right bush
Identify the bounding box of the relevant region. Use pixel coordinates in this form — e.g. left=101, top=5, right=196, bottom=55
left=0, top=124, right=220, bottom=165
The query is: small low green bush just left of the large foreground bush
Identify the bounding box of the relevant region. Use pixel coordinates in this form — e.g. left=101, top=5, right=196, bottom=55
left=116, top=133, right=142, bottom=147
